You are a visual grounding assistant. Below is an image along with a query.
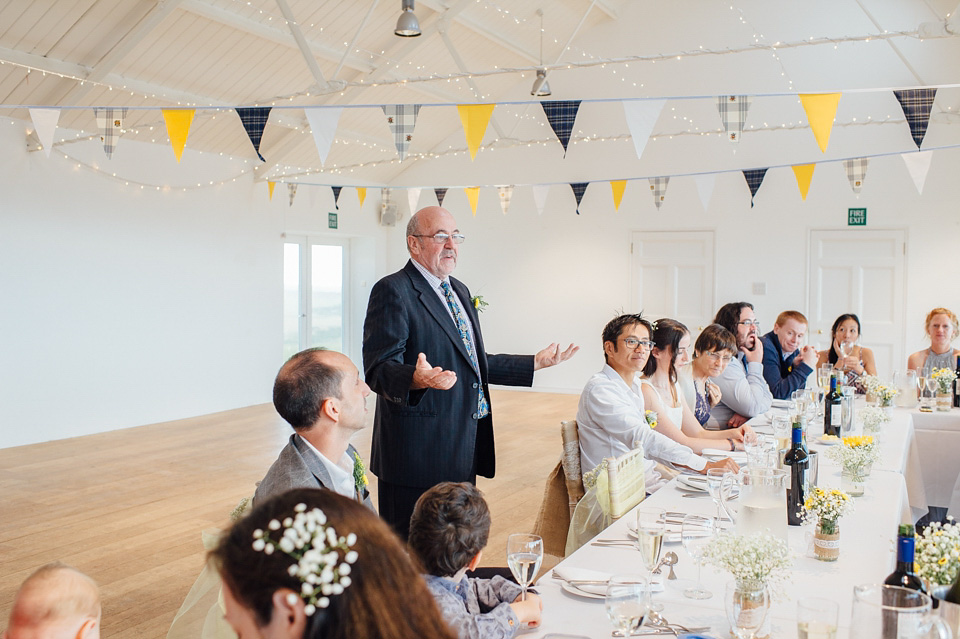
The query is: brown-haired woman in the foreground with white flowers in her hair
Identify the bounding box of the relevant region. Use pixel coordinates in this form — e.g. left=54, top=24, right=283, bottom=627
left=210, top=488, right=455, bottom=639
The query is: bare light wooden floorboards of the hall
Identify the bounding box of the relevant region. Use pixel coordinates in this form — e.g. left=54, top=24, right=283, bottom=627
left=0, top=390, right=577, bottom=639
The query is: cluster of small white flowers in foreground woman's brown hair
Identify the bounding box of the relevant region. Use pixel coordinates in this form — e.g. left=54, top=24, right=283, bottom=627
left=253, top=504, right=358, bottom=617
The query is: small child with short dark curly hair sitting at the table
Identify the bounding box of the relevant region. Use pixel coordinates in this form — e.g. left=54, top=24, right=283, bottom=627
left=408, top=482, right=543, bottom=639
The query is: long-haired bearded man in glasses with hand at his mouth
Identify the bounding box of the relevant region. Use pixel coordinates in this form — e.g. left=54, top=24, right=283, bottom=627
left=710, top=302, right=773, bottom=428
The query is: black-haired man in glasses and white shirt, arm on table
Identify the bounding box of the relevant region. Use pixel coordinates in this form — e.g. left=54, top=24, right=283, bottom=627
left=577, top=314, right=738, bottom=492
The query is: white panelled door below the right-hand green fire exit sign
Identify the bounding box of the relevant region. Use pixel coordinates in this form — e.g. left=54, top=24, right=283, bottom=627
left=808, top=229, right=907, bottom=380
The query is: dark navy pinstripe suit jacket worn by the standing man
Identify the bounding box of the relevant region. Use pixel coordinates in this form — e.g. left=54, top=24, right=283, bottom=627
left=363, top=260, right=533, bottom=488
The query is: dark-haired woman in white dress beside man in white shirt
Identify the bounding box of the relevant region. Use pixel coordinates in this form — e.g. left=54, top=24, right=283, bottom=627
left=641, top=319, right=753, bottom=454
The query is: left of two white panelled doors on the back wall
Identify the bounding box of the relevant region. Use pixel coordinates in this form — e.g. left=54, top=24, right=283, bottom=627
left=631, top=231, right=716, bottom=330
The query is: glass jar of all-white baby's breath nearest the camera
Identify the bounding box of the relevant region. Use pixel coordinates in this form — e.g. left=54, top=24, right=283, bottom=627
left=704, top=531, right=793, bottom=639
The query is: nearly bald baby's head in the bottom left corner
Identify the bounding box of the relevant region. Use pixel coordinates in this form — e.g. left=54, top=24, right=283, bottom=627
left=3, top=563, right=100, bottom=639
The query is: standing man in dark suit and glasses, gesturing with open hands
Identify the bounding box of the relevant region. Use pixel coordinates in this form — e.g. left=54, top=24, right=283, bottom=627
left=363, top=206, right=578, bottom=539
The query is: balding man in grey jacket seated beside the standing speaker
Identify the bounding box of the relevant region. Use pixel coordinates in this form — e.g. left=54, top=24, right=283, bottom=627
left=253, top=348, right=373, bottom=510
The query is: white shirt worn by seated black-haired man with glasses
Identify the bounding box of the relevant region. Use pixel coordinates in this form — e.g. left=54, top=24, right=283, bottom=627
left=577, top=364, right=707, bottom=491
